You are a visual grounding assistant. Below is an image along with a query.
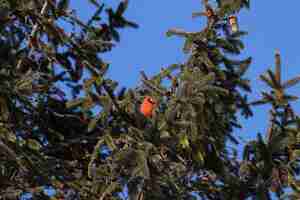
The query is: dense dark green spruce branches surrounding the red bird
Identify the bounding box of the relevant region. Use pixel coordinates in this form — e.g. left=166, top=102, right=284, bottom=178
left=0, top=0, right=300, bottom=200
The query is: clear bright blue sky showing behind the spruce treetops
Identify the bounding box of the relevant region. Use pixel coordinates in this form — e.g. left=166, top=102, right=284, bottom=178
left=72, top=0, right=300, bottom=145
